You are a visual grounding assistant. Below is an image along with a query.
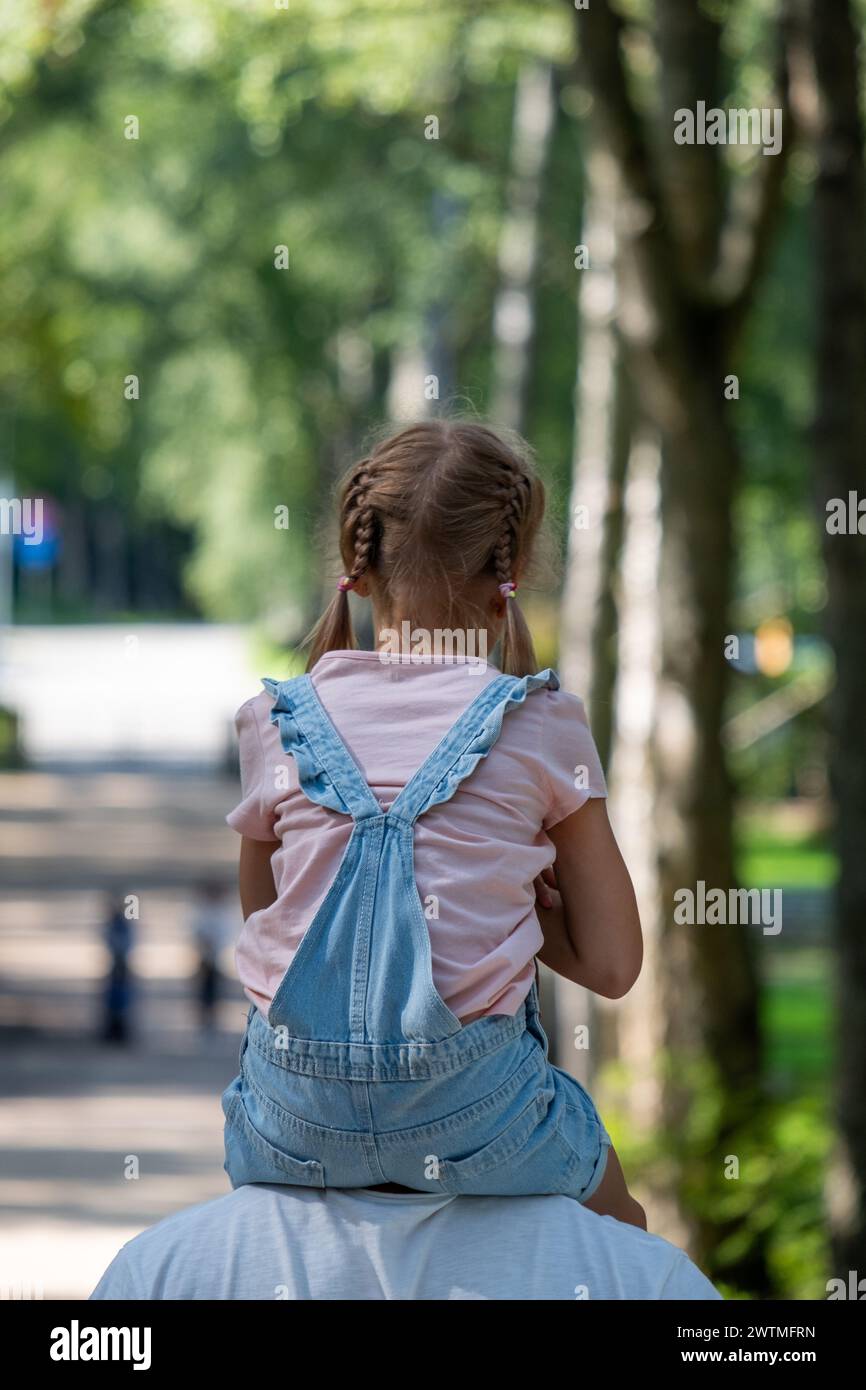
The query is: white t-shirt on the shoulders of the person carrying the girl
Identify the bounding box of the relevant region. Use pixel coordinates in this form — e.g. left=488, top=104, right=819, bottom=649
left=90, top=1184, right=721, bottom=1301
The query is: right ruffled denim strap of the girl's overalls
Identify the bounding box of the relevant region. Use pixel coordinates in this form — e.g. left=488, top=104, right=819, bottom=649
left=388, top=669, right=559, bottom=821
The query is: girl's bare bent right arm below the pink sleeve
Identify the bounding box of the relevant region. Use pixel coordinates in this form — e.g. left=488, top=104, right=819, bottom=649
left=537, top=796, right=644, bottom=999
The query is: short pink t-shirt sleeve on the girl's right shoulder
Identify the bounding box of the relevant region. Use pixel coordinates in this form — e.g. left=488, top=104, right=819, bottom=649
left=539, top=691, right=607, bottom=830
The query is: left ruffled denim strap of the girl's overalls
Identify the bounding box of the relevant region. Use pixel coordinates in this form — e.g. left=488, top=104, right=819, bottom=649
left=261, top=676, right=382, bottom=820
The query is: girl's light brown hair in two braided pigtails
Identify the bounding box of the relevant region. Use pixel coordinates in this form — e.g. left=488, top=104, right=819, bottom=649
left=307, top=420, right=545, bottom=676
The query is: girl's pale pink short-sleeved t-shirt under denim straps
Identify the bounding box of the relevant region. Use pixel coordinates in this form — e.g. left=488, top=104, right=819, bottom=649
left=227, top=652, right=607, bottom=1023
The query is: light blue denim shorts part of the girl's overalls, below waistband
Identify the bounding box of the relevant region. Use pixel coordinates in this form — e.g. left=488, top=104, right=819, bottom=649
left=222, top=1008, right=610, bottom=1201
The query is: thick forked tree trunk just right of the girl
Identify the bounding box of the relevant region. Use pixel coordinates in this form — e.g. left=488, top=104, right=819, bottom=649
left=575, top=0, right=790, bottom=1289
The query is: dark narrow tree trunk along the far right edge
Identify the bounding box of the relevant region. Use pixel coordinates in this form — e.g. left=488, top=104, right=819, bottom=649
left=809, top=0, right=866, bottom=1277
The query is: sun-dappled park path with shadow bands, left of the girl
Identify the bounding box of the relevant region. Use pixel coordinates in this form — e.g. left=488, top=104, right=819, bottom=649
left=0, top=771, right=246, bottom=1298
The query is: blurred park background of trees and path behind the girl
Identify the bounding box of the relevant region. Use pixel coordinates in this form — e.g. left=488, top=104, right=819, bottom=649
left=0, top=0, right=866, bottom=1298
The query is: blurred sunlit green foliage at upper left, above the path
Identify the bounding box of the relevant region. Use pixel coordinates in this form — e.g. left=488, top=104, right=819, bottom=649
left=0, top=0, right=573, bottom=635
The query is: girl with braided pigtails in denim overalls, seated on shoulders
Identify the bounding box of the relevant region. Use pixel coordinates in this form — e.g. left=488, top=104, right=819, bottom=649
left=222, top=421, right=645, bottom=1227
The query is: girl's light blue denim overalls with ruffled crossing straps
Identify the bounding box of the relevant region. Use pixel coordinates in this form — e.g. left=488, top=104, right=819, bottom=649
left=222, top=670, right=610, bottom=1201
